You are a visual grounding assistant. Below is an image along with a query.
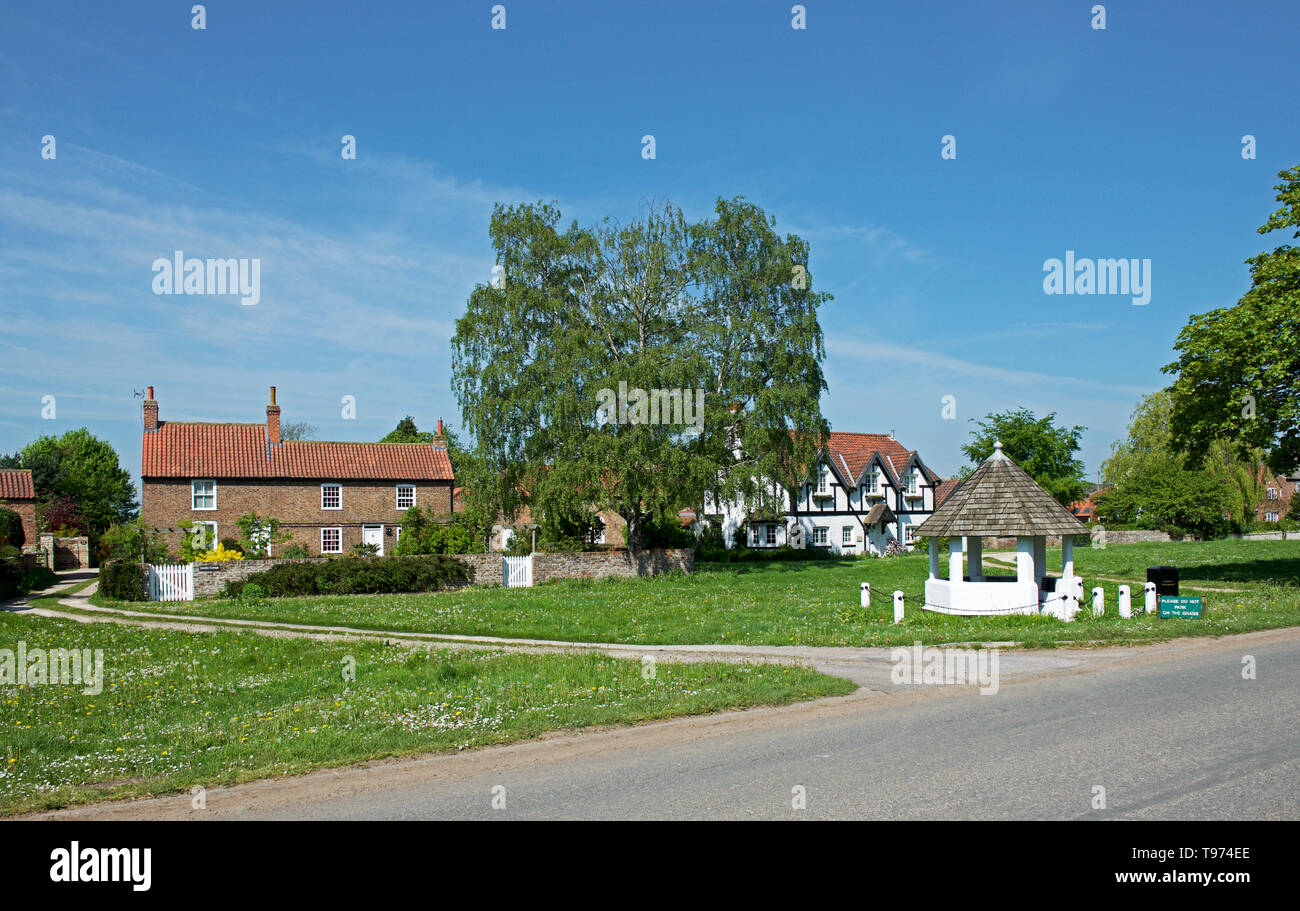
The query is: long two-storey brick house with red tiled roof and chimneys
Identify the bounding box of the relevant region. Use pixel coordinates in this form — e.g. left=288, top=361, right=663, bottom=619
left=140, top=386, right=454, bottom=555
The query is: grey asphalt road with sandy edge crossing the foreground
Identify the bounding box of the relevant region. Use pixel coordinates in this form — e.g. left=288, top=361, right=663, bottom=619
left=35, top=630, right=1300, bottom=821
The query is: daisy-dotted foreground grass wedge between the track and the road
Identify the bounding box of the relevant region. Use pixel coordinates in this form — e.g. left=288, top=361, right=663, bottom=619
left=0, top=592, right=855, bottom=815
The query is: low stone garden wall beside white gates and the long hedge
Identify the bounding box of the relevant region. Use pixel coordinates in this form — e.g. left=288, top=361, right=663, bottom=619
left=194, top=550, right=696, bottom=598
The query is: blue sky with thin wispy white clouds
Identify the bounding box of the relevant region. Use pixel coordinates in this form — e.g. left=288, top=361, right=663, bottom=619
left=0, top=0, right=1300, bottom=491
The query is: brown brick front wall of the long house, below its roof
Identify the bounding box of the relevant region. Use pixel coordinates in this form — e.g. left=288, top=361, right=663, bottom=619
left=140, top=478, right=452, bottom=555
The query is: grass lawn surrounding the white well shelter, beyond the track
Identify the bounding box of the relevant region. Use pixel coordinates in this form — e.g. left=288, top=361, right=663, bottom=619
left=91, top=541, right=1300, bottom=647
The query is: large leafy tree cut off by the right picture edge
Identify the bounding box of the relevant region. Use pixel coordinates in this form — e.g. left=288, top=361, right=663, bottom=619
left=1164, top=166, right=1300, bottom=472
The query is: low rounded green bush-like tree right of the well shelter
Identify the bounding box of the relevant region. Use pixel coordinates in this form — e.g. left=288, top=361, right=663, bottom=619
left=1096, top=463, right=1227, bottom=537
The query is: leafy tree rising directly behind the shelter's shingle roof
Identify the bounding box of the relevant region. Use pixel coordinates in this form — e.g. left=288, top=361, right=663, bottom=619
left=962, top=408, right=1088, bottom=506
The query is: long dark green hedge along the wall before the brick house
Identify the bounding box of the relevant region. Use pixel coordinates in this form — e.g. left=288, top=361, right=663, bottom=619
left=226, top=554, right=473, bottom=598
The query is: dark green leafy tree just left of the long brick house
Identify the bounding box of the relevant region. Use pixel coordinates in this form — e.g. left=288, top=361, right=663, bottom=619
left=9, top=428, right=137, bottom=538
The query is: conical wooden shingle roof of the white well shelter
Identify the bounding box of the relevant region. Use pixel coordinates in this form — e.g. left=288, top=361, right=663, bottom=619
left=917, top=443, right=1088, bottom=538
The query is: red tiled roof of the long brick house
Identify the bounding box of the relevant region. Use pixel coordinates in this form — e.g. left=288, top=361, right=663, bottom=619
left=140, top=421, right=452, bottom=481
